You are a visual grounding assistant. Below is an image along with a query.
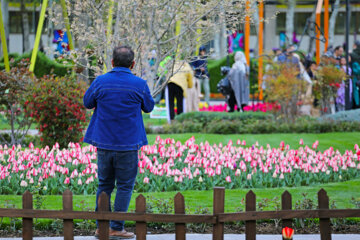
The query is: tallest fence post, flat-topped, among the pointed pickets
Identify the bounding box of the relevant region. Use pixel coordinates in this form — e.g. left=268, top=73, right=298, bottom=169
left=213, top=187, right=225, bottom=240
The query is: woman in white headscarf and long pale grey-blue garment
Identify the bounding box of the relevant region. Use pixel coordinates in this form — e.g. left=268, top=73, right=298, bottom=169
left=228, top=52, right=250, bottom=112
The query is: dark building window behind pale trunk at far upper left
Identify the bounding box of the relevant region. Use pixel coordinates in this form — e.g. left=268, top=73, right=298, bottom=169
left=9, top=11, right=39, bottom=33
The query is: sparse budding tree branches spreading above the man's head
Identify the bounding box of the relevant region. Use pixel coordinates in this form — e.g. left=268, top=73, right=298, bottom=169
left=53, top=0, right=262, bottom=95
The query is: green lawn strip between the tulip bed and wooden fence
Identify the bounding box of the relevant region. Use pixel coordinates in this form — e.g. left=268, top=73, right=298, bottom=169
left=0, top=179, right=360, bottom=212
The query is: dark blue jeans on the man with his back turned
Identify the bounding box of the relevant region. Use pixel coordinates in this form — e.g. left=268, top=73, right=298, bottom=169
left=95, top=149, right=138, bottom=231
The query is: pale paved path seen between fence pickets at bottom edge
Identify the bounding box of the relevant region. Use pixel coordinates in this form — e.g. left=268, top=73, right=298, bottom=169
left=0, top=234, right=360, bottom=240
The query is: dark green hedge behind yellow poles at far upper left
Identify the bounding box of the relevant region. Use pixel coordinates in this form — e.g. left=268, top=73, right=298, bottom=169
left=0, top=52, right=73, bottom=78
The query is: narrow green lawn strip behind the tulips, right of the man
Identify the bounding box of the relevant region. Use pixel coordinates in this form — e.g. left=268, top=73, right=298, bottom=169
left=148, top=132, right=360, bottom=152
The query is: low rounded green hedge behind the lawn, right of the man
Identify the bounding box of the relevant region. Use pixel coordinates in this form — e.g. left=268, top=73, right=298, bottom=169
left=146, top=112, right=360, bottom=134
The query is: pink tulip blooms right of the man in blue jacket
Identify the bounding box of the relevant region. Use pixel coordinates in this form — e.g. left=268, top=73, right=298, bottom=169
left=139, top=136, right=360, bottom=187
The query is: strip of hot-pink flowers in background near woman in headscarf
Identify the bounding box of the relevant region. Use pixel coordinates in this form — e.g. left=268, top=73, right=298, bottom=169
left=199, top=103, right=280, bottom=112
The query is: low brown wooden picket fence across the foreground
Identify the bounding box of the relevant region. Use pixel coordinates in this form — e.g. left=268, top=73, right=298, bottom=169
left=0, top=187, right=360, bottom=240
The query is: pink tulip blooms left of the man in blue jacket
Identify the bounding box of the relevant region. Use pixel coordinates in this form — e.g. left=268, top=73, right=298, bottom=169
left=0, top=143, right=97, bottom=191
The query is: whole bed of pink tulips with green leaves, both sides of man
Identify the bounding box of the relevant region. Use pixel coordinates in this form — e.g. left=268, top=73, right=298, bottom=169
left=0, top=136, right=360, bottom=194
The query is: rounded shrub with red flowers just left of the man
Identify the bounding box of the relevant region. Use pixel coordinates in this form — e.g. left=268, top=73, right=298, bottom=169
left=25, top=75, right=86, bottom=147
